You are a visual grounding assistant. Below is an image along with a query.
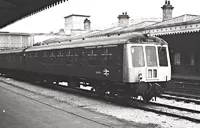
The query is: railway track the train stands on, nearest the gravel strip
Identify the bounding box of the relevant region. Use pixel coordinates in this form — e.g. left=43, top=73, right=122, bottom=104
left=1, top=75, right=200, bottom=123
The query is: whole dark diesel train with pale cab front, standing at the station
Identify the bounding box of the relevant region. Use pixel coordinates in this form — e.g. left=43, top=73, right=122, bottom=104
left=0, top=34, right=171, bottom=102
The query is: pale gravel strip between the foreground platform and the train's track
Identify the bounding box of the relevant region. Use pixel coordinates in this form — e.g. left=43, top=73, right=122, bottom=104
left=0, top=77, right=200, bottom=128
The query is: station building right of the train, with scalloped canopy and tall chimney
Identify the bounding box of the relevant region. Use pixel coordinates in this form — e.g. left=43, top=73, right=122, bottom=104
left=134, top=1, right=200, bottom=80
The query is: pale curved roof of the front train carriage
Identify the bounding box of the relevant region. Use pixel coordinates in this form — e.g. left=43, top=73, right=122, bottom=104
left=25, top=33, right=167, bottom=52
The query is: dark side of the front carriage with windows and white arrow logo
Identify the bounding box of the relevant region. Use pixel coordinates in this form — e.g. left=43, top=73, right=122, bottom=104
left=25, top=44, right=123, bottom=82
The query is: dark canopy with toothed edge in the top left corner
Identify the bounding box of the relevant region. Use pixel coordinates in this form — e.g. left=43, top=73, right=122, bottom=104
left=0, top=0, right=67, bottom=28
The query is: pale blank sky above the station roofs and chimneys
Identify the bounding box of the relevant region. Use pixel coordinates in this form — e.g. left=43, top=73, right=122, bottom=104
left=0, top=0, right=200, bottom=33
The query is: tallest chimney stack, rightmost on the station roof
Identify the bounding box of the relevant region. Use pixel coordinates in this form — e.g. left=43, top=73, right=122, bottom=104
left=161, top=0, right=174, bottom=21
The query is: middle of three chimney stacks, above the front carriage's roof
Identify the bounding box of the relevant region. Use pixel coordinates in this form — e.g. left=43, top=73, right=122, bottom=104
left=117, top=12, right=130, bottom=27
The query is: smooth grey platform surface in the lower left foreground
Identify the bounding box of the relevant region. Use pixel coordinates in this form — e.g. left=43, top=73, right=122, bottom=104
left=0, top=83, right=143, bottom=128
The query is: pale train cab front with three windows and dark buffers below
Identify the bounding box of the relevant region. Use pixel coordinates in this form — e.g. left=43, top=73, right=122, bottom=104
left=124, top=35, right=171, bottom=102
